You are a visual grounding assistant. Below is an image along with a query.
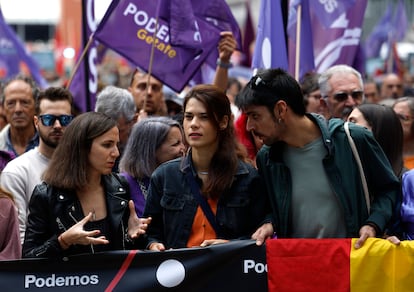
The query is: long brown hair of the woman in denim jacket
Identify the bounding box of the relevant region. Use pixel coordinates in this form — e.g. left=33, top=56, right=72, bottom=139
left=183, top=84, right=247, bottom=197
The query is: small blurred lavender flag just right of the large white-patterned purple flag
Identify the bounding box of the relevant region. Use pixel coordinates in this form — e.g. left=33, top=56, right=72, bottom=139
left=365, top=3, right=392, bottom=58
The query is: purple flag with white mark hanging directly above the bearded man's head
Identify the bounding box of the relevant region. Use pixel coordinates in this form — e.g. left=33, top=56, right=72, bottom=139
left=252, top=0, right=288, bottom=70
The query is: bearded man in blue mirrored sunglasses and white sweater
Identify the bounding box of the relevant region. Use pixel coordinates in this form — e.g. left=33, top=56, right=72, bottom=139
left=0, top=87, right=73, bottom=243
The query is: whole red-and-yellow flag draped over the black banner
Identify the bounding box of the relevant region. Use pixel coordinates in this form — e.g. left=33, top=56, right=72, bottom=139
left=266, top=238, right=414, bottom=292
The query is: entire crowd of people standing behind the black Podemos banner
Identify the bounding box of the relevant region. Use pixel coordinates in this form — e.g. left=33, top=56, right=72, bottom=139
left=0, top=32, right=414, bottom=268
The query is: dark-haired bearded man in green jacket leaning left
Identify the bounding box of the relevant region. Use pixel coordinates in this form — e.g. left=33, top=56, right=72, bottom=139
left=236, top=69, right=400, bottom=248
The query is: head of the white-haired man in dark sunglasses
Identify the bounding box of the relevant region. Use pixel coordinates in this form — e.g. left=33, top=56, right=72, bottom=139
left=319, top=65, right=364, bottom=120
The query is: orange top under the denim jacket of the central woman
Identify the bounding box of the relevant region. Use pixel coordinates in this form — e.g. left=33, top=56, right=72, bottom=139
left=187, top=199, right=218, bottom=247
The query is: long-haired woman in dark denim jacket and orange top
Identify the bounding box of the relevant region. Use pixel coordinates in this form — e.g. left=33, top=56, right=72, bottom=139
left=144, top=85, right=269, bottom=251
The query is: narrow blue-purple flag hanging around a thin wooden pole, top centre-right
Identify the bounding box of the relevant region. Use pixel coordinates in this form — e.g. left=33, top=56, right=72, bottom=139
left=288, top=0, right=315, bottom=80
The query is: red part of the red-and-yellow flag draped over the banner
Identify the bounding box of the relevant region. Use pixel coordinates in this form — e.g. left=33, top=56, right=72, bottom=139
left=266, top=239, right=351, bottom=292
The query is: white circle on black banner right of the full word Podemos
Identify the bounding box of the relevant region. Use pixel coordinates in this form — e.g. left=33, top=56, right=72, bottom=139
left=156, top=260, right=185, bottom=288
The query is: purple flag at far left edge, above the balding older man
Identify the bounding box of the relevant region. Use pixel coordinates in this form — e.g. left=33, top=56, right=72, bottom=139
left=0, top=10, right=48, bottom=88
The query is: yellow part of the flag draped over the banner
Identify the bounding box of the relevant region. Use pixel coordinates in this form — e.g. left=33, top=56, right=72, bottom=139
left=350, top=238, right=414, bottom=292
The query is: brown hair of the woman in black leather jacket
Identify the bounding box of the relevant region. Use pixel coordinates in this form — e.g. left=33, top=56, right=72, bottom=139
left=42, top=112, right=117, bottom=189
